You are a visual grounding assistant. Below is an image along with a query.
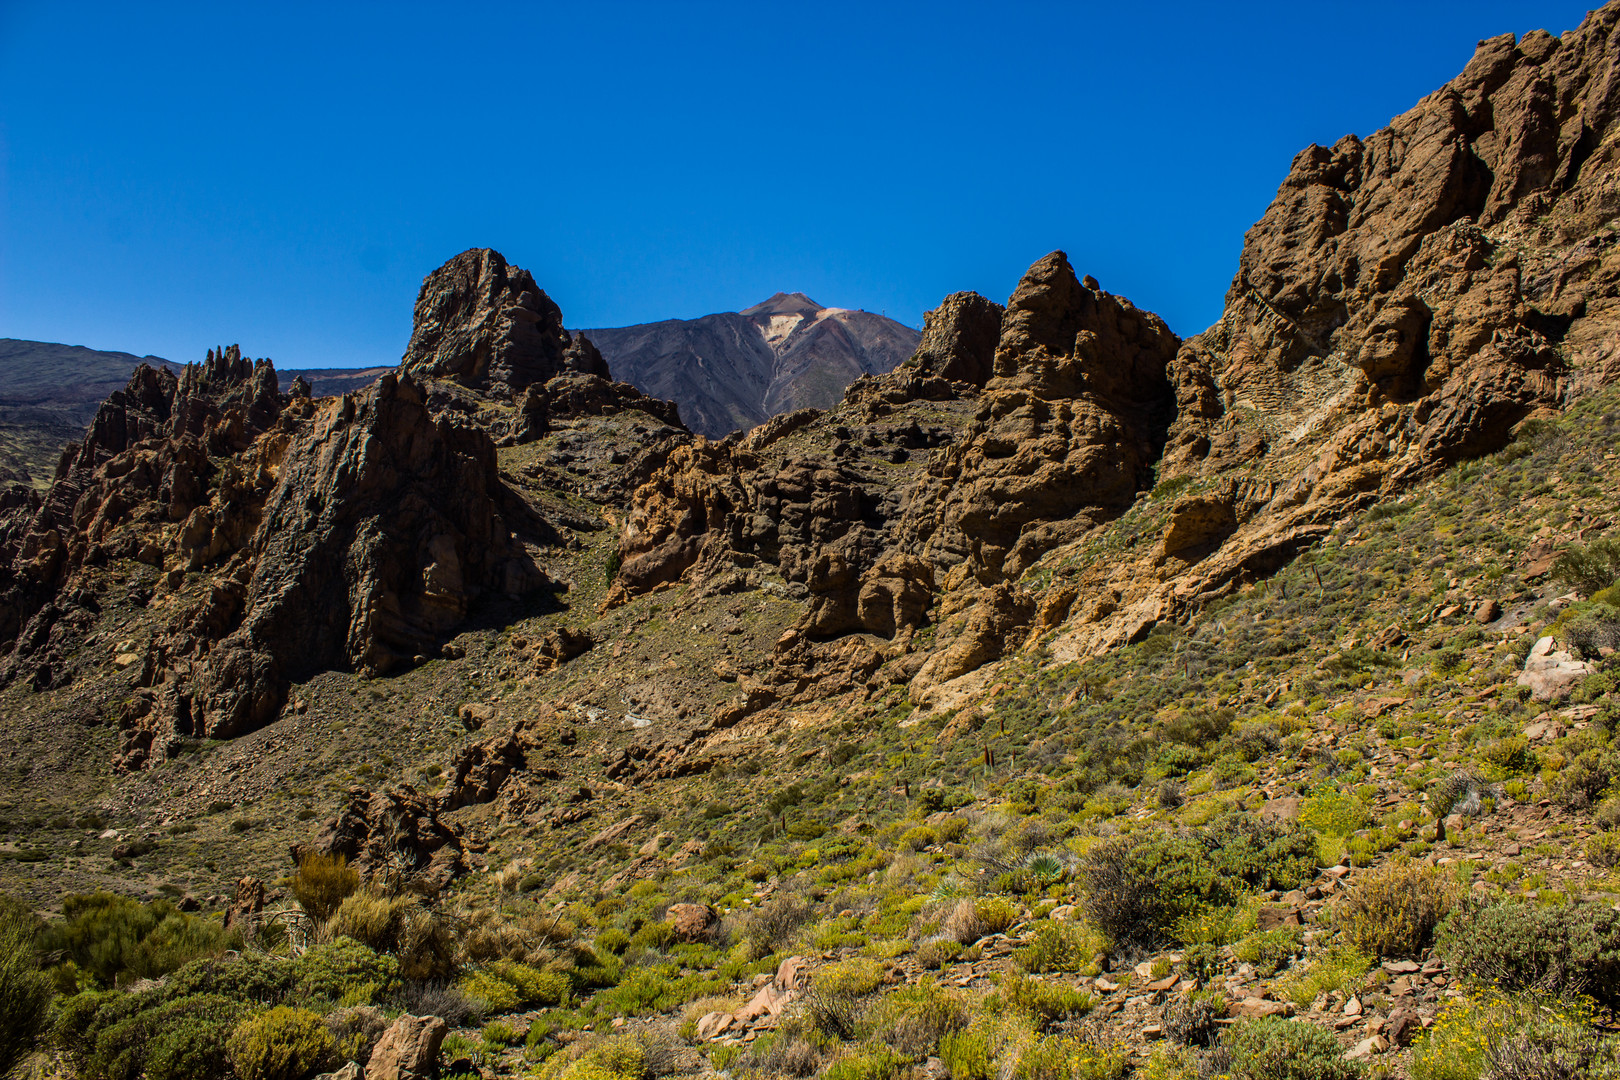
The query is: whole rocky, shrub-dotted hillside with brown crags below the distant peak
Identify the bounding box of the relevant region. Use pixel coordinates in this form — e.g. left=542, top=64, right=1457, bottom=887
left=0, top=3, right=1620, bottom=1080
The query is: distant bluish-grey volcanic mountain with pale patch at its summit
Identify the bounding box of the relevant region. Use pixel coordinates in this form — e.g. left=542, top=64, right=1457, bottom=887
left=583, top=293, right=917, bottom=439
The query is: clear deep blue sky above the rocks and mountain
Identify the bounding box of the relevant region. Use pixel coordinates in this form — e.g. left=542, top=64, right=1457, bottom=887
left=0, top=0, right=1588, bottom=368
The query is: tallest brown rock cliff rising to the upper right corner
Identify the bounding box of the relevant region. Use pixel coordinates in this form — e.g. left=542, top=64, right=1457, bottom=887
left=1166, top=19, right=1620, bottom=473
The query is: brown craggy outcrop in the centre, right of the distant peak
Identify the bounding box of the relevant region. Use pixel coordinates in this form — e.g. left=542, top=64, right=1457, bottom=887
left=609, top=253, right=1179, bottom=699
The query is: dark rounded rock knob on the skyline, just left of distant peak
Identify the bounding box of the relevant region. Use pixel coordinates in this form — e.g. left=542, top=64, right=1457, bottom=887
left=400, top=248, right=608, bottom=397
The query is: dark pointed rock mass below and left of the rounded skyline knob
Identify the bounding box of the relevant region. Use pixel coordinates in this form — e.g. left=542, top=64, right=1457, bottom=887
left=120, top=374, right=546, bottom=767
